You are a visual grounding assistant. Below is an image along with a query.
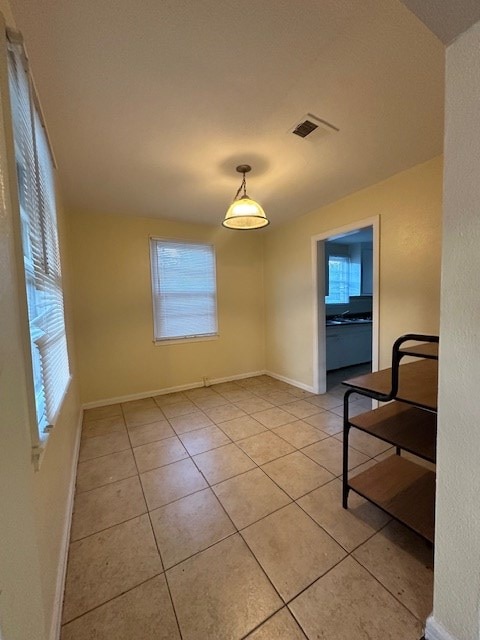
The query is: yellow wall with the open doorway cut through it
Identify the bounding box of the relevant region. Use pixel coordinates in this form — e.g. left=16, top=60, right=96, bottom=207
left=265, top=158, right=442, bottom=386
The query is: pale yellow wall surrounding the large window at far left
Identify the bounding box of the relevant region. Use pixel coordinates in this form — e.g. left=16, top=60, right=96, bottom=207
left=0, top=0, right=80, bottom=640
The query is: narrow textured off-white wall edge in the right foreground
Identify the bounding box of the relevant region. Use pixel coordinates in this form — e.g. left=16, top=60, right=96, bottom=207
left=426, top=22, right=480, bottom=640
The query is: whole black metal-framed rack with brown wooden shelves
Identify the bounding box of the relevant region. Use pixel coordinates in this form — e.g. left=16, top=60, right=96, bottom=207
left=343, top=334, right=438, bottom=543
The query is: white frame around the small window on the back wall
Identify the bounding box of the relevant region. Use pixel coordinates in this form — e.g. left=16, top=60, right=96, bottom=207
left=149, top=236, right=220, bottom=346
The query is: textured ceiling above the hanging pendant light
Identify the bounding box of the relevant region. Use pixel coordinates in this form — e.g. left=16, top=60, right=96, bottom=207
left=10, top=0, right=444, bottom=226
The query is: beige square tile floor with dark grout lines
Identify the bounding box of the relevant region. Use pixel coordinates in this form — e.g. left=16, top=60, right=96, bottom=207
left=62, top=376, right=433, bottom=640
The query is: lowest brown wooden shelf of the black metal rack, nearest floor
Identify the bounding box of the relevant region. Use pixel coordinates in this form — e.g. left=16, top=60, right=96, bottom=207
left=348, top=455, right=435, bottom=543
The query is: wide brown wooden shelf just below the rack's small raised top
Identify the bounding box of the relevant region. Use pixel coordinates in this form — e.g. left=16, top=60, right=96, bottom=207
left=343, top=359, right=438, bottom=411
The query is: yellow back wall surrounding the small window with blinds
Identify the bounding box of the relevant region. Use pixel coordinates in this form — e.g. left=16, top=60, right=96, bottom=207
left=69, top=212, right=264, bottom=402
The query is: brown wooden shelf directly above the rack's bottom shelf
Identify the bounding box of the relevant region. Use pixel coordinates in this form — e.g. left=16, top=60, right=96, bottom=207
left=349, top=402, right=437, bottom=462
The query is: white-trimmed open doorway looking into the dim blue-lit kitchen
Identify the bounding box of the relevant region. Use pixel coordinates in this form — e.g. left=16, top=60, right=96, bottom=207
left=312, top=216, right=379, bottom=393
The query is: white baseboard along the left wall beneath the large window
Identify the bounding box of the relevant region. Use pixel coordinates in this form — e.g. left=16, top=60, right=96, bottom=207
left=49, top=409, right=83, bottom=640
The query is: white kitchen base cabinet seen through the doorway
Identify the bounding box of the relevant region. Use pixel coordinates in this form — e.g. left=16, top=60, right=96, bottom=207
left=326, top=323, right=372, bottom=371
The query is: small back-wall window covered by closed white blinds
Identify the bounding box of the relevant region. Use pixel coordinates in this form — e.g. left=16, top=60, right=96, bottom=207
left=150, top=238, right=217, bottom=341
